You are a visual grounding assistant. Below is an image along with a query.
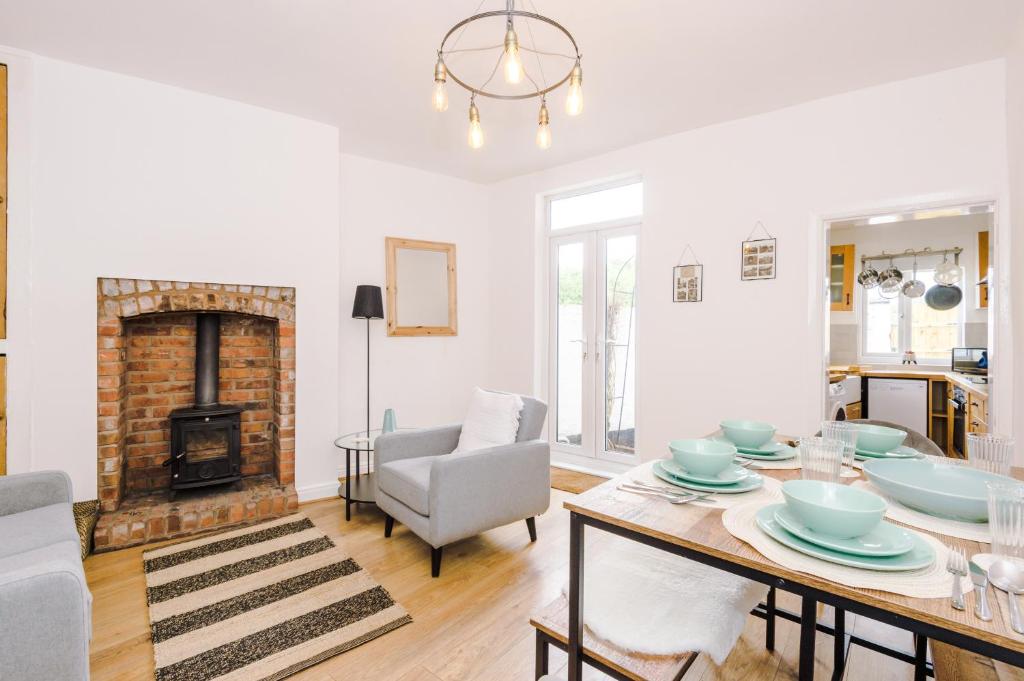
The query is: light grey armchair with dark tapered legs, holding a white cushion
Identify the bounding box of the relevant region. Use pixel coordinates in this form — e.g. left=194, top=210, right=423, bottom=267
left=374, top=395, right=551, bottom=577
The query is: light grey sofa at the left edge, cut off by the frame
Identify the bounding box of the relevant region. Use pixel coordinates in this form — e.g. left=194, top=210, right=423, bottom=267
left=0, top=471, right=92, bottom=681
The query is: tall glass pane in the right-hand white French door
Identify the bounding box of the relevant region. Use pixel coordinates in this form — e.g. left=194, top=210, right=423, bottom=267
left=604, top=235, right=637, bottom=454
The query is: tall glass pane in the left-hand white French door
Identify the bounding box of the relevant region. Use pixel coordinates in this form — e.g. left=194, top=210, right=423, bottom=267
left=555, top=242, right=584, bottom=445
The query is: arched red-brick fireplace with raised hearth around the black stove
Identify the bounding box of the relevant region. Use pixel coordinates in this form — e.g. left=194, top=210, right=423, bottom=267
left=94, top=279, right=297, bottom=551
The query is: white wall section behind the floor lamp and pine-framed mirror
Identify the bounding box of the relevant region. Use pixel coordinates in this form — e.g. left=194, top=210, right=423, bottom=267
left=339, top=155, right=491, bottom=460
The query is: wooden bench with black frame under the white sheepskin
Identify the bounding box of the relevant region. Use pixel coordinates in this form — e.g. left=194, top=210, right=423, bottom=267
left=529, top=596, right=697, bottom=681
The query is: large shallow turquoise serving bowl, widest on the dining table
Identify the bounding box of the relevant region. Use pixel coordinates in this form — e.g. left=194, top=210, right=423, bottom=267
left=864, top=459, right=1014, bottom=522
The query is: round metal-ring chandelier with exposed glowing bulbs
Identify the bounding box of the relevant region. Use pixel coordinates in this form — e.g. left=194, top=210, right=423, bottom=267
left=433, top=0, right=583, bottom=148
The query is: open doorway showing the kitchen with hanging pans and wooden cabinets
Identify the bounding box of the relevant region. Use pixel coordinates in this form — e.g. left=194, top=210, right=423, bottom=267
left=823, top=201, right=996, bottom=458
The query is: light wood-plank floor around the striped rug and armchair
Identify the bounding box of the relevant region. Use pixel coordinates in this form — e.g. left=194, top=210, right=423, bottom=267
left=85, top=491, right=1011, bottom=681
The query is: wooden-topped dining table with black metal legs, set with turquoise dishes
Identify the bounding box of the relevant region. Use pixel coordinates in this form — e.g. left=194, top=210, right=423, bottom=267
left=564, top=435, right=1024, bottom=681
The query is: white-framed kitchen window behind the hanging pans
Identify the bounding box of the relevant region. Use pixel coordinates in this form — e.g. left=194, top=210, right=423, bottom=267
left=861, top=269, right=965, bottom=365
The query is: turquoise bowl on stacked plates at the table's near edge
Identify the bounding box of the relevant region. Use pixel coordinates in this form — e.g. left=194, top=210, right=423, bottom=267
left=782, top=480, right=886, bottom=539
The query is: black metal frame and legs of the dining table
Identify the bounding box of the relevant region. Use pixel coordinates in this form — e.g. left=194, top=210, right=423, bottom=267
left=569, top=511, right=1024, bottom=681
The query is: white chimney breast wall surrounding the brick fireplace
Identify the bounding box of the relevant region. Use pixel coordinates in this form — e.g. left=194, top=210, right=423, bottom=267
left=17, top=57, right=339, bottom=499
